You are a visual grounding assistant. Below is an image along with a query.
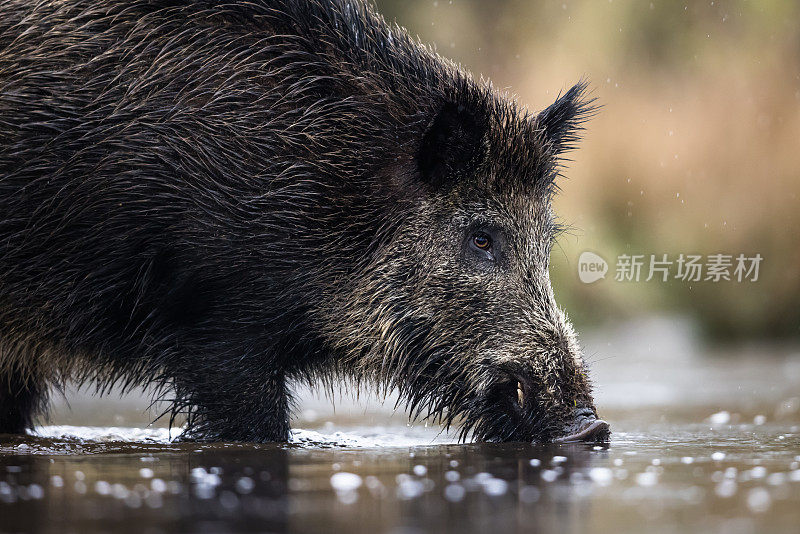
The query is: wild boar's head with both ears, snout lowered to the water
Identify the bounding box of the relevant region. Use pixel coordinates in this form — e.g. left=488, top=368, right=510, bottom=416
left=318, top=84, right=609, bottom=442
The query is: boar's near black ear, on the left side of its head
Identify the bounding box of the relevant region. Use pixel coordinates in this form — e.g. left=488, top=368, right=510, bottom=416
left=417, top=102, right=488, bottom=186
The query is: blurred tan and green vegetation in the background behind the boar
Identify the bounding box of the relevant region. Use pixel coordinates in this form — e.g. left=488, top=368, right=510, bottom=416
left=377, top=0, right=800, bottom=340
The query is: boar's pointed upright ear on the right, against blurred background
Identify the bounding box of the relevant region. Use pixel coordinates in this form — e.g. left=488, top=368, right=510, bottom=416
left=536, top=81, right=597, bottom=153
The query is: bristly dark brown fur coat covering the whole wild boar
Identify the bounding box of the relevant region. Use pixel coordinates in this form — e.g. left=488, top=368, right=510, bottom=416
left=0, top=0, right=595, bottom=441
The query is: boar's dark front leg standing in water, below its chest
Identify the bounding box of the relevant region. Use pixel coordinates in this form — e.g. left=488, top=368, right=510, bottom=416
left=173, top=360, right=290, bottom=442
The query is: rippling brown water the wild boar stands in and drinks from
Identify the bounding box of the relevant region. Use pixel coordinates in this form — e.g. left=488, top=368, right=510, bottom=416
left=0, top=323, right=800, bottom=533
